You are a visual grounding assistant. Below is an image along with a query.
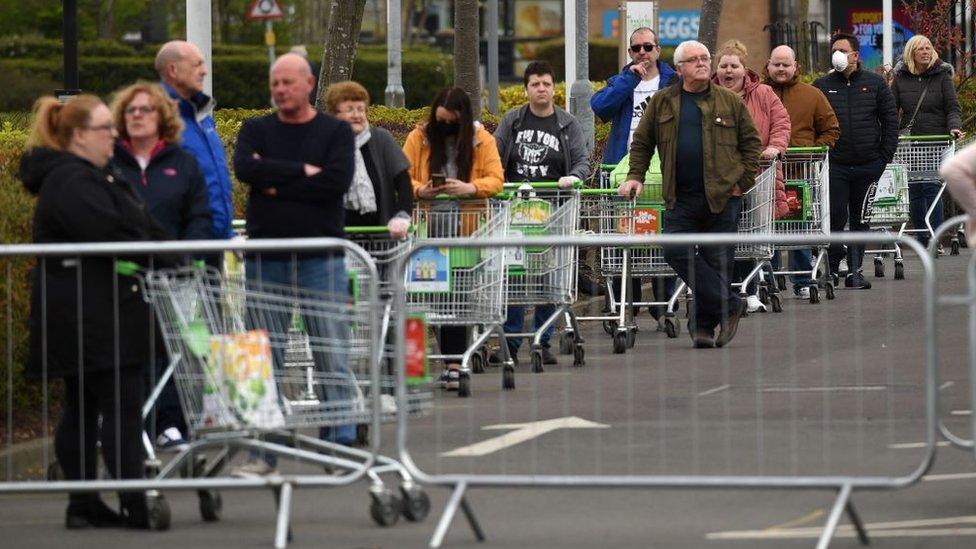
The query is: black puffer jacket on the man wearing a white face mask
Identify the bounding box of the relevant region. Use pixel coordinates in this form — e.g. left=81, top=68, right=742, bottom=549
left=813, top=68, right=898, bottom=166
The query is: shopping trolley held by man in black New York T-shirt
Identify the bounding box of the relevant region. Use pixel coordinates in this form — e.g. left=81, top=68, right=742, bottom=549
left=499, top=182, right=585, bottom=378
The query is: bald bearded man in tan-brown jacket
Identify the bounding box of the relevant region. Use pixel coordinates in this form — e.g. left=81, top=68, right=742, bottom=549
left=764, top=46, right=840, bottom=299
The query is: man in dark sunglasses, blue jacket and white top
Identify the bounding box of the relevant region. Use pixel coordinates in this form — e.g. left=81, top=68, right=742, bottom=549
left=590, top=27, right=677, bottom=164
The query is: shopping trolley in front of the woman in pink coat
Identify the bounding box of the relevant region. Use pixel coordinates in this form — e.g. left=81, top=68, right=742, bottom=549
left=732, top=160, right=783, bottom=313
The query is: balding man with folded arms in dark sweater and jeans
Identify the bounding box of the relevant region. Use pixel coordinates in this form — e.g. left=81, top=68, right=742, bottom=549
left=234, top=53, right=356, bottom=475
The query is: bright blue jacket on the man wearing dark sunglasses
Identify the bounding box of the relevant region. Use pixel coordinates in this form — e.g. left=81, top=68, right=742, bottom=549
left=590, top=59, right=678, bottom=164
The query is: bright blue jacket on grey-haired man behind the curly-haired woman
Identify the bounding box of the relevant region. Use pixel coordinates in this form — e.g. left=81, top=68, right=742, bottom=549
left=162, top=82, right=234, bottom=238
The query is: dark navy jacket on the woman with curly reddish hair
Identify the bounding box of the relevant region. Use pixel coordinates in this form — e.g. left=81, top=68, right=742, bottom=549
left=113, top=142, right=213, bottom=240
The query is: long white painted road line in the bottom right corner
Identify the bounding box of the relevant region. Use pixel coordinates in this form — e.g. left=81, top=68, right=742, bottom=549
left=705, top=515, right=976, bottom=540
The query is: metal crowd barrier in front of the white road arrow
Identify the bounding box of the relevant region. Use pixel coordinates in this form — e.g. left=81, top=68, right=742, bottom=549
left=395, top=233, right=938, bottom=548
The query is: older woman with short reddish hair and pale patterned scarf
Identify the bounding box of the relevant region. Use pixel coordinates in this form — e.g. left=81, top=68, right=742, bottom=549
left=325, top=80, right=413, bottom=238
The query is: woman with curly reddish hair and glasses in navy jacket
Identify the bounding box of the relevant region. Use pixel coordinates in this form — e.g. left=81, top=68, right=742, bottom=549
left=111, top=82, right=213, bottom=450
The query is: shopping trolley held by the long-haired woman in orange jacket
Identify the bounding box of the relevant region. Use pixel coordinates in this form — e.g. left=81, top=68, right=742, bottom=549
left=404, top=195, right=509, bottom=397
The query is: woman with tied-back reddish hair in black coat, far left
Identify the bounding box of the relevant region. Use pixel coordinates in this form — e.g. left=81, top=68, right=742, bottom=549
left=20, top=95, right=163, bottom=528
